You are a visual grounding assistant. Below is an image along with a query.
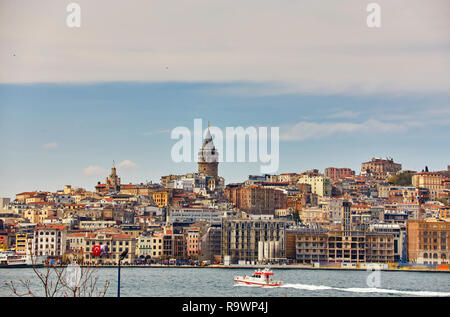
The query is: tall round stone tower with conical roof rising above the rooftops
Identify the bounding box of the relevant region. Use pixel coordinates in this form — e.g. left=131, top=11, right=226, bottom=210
left=198, top=122, right=219, bottom=179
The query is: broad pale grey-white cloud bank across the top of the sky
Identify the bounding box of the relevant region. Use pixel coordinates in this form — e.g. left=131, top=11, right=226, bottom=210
left=0, top=0, right=450, bottom=93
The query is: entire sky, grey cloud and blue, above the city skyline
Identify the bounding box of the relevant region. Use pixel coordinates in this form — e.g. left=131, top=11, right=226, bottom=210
left=0, top=0, right=450, bottom=197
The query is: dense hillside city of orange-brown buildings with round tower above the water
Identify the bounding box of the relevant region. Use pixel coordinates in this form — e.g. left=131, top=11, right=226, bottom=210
left=0, top=123, right=450, bottom=269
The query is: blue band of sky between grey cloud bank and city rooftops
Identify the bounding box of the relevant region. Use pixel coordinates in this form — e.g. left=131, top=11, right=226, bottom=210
left=0, top=82, right=450, bottom=197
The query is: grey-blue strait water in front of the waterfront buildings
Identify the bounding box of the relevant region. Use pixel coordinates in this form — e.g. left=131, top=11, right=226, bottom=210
left=0, top=268, right=450, bottom=297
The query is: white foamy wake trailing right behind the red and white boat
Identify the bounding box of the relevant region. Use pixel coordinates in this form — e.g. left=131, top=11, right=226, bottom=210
left=281, top=284, right=450, bottom=297
